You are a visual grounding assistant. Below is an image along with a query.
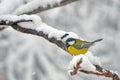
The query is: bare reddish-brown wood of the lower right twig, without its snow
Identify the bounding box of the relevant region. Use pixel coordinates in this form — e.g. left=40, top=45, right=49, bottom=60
left=71, top=59, right=120, bottom=80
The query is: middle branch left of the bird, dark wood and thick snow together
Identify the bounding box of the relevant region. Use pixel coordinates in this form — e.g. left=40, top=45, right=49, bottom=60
left=0, top=15, right=78, bottom=50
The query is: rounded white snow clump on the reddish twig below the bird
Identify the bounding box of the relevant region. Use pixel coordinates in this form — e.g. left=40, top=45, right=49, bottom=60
left=68, top=51, right=101, bottom=73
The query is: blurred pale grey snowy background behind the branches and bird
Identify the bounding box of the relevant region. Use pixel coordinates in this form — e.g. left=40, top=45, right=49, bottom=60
left=0, top=0, right=120, bottom=80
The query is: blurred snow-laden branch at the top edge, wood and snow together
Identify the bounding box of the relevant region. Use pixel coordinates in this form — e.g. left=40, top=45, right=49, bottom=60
left=13, top=0, right=78, bottom=15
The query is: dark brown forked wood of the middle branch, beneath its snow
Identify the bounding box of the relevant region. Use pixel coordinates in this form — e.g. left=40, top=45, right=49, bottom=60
left=0, top=20, right=66, bottom=50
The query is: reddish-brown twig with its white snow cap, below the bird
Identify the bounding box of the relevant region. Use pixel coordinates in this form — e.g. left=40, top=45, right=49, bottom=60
left=69, top=55, right=120, bottom=80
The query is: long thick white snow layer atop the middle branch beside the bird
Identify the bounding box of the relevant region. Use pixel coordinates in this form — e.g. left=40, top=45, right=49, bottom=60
left=0, top=14, right=79, bottom=43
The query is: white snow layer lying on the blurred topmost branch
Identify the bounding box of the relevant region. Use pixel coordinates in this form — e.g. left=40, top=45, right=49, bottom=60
left=13, top=0, right=62, bottom=15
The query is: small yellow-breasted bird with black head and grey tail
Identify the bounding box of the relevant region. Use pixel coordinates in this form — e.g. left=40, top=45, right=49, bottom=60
left=66, top=38, right=103, bottom=56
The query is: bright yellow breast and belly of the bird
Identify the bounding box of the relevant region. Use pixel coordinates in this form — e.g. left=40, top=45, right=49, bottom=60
left=67, top=46, right=88, bottom=55
